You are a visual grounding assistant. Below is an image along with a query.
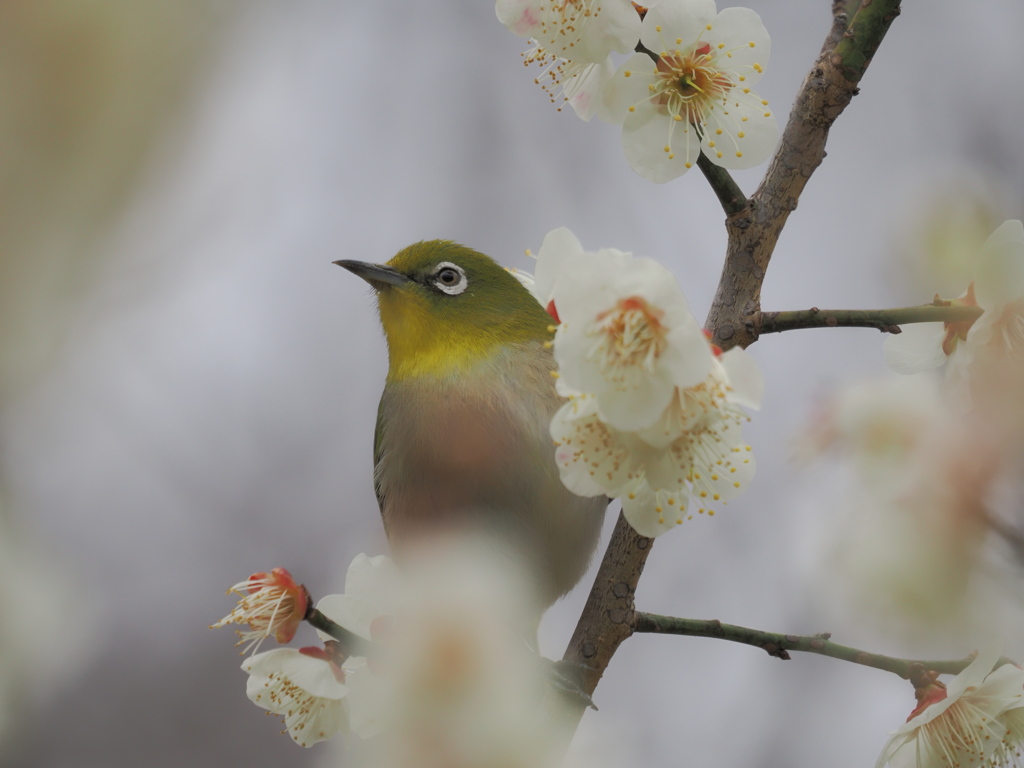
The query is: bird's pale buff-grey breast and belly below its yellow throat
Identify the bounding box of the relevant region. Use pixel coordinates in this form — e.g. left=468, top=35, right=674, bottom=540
left=375, top=343, right=607, bottom=604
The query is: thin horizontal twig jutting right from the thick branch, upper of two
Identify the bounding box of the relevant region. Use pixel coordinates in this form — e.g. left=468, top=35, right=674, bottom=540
left=751, top=304, right=982, bottom=335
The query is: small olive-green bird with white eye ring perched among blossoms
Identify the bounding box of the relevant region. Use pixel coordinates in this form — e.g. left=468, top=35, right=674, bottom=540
left=334, top=240, right=608, bottom=608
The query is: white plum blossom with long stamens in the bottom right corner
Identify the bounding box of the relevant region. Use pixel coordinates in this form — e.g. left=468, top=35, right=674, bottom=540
left=876, top=649, right=1024, bottom=768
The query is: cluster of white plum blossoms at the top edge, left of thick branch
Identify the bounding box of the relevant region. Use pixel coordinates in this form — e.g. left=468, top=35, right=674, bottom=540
left=496, top=0, right=778, bottom=183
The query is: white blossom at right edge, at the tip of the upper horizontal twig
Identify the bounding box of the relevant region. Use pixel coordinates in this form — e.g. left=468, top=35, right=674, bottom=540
left=885, top=219, right=1024, bottom=376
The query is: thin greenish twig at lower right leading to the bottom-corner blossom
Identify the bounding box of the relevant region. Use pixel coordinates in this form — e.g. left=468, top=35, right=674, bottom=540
left=633, top=611, right=1013, bottom=680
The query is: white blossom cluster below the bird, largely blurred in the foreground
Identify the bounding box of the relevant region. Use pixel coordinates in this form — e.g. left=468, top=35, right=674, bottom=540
left=214, top=541, right=556, bottom=768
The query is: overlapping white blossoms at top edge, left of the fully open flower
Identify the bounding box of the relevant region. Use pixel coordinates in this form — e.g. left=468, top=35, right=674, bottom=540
left=495, top=0, right=640, bottom=120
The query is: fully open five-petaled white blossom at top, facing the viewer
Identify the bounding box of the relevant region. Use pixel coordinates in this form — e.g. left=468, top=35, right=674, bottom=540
left=606, top=0, right=778, bottom=183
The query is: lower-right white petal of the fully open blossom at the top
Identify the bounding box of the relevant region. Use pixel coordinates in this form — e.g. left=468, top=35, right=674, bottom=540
left=701, top=88, right=778, bottom=170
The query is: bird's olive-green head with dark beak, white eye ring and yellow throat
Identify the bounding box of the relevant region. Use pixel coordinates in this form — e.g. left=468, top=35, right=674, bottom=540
left=335, top=240, right=551, bottom=379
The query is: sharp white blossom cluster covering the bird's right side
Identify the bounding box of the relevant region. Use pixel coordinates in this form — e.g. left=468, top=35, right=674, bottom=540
left=520, top=228, right=764, bottom=537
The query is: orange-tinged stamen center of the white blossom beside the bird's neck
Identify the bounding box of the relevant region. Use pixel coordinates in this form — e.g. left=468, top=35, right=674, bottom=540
left=587, top=296, right=669, bottom=381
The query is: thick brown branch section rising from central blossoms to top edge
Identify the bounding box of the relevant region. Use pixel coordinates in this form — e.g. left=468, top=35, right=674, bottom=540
left=705, top=0, right=899, bottom=349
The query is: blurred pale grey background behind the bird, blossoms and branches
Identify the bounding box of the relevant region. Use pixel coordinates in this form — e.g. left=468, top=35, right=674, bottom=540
left=0, top=0, right=1024, bottom=768
